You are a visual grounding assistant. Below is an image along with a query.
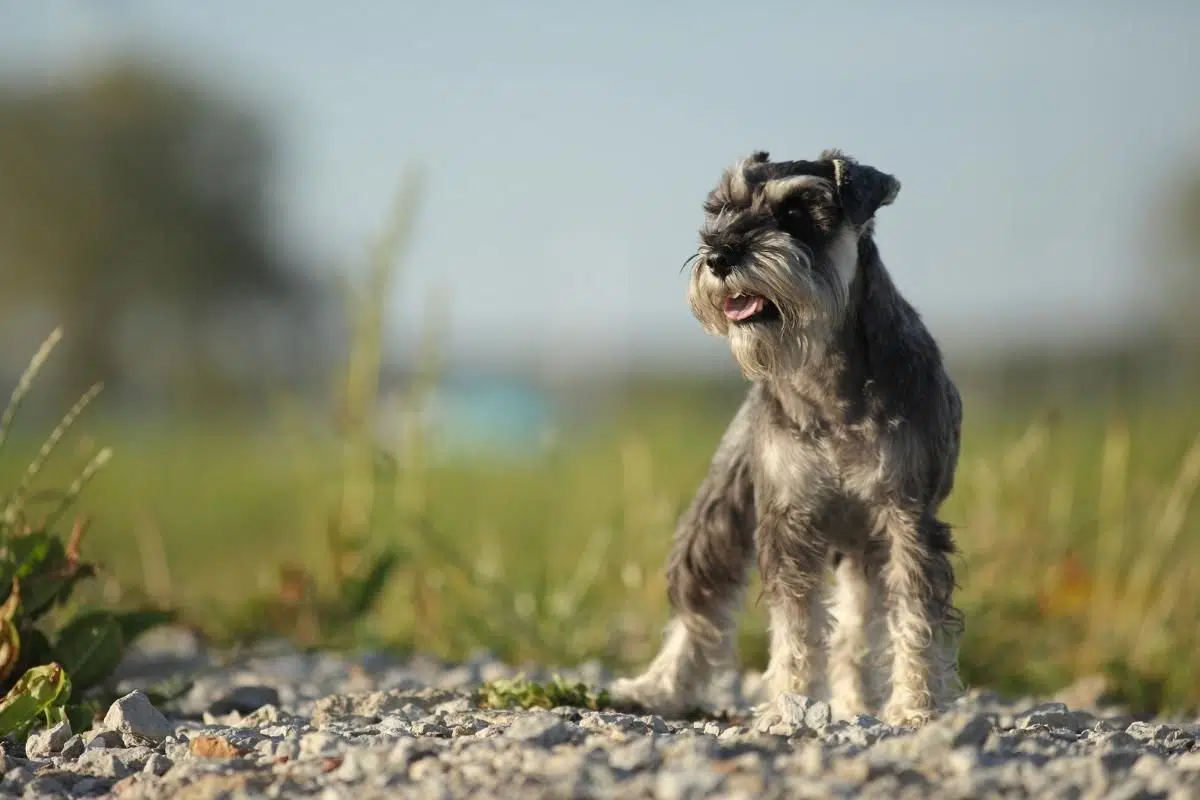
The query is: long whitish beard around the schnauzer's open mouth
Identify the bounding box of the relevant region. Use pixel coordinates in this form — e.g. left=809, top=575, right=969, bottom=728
left=688, top=233, right=853, bottom=379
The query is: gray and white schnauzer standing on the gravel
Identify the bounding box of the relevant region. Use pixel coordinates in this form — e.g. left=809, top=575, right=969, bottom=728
left=613, top=150, right=962, bottom=726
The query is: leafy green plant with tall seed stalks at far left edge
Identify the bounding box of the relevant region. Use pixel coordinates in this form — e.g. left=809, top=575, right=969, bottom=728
left=0, top=330, right=172, bottom=735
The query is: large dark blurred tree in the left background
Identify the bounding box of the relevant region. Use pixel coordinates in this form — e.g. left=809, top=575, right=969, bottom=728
left=0, top=62, right=333, bottom=407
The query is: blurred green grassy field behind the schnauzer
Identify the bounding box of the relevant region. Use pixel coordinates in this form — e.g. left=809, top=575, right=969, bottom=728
left=6, top=371, right=1200, bottom=708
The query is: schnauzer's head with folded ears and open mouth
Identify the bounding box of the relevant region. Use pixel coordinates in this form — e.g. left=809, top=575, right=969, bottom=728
left=688, top=150, right=900, bottom=377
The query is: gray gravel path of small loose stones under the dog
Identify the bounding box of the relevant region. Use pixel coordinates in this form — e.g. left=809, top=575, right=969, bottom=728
left=0, top=636, right=1200, bottom=800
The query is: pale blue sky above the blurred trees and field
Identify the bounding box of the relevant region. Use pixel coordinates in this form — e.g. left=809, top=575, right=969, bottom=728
left=0, top=0, right=1200, bottom=369
